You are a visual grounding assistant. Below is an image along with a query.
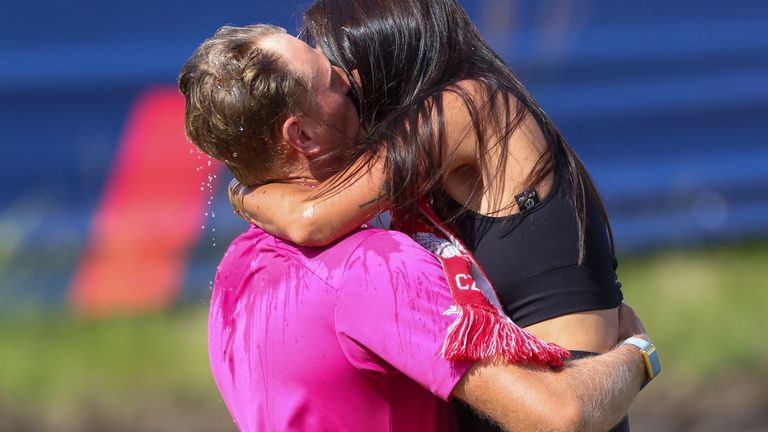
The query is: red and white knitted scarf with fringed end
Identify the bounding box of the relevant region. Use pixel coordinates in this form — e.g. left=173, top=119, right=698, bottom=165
left=395, top=200, right=570, bottom=366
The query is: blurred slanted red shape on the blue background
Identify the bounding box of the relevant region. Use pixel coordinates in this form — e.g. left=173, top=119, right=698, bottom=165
left=70, top=87, right=220, bottom=317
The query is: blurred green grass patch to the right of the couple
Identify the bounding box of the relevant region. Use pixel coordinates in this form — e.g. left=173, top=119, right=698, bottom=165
left=619, top=243, right=768, bottom=382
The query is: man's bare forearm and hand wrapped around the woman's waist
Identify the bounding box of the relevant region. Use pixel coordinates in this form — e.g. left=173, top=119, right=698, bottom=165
left=453, top=305, right=648, bottom=431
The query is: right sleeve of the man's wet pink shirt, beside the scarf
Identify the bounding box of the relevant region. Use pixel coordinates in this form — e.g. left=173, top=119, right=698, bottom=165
left=336, top=231, right=471, bottom=400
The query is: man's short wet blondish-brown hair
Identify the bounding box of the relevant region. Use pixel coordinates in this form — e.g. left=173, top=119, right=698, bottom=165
left=179, top=24, right=315, bottom=186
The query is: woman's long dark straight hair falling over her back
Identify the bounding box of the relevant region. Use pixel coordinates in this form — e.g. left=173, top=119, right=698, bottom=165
left=302, top=0, right=613, bottom=261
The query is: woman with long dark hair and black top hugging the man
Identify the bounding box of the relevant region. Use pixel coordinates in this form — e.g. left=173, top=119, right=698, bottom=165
left=231, top=0, right=628, bottom=430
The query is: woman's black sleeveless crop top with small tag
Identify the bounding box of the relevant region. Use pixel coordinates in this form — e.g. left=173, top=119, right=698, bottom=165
left=453, top=177, right=629, bottom=431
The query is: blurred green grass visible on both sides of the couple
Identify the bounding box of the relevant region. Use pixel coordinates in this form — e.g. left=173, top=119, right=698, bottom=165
left=0, top=243, right=768, bottom=421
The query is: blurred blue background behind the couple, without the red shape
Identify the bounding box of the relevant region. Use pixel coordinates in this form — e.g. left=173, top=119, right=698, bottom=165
left=0, top=0, right=768, bottom=310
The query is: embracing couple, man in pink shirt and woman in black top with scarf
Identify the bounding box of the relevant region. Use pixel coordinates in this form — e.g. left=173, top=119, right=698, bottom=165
left=179, top=0, right=659, bottom=431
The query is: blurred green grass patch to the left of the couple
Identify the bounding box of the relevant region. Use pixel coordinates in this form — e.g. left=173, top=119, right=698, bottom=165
left=0, top=307, right=218, bottom=410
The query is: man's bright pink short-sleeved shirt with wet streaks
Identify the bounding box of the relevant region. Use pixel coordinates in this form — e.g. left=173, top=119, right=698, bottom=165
left=208, top=226, right=469, bottom=432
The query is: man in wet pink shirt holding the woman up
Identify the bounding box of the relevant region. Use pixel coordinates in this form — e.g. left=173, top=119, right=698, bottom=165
left=179, top=25, right=660, bottom=431
